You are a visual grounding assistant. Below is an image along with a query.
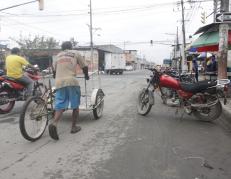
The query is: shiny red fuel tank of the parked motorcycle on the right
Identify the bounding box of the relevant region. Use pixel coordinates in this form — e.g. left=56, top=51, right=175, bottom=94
left=160, top=75, right=180, bottom=90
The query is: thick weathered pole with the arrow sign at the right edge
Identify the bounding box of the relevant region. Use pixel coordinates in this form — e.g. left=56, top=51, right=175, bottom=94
left=217, top=0, right=229, bottom=79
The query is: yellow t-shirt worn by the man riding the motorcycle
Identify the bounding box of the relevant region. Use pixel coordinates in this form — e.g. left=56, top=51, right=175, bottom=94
left=6, top=55, right=29, bottom=79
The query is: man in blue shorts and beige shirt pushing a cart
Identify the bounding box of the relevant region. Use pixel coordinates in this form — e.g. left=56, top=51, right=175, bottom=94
left=49, top=41, right=89, bottom=140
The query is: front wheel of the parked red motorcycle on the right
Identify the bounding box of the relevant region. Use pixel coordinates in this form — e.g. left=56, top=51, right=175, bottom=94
left=137, top=88, right=152, bottom=116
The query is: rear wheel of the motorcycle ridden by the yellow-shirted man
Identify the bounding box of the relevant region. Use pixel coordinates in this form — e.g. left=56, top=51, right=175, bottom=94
left=0, top=89, right=15, bottom=114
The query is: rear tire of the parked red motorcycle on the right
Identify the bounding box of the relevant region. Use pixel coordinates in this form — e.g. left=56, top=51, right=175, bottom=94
left=193, top=101, right=222, bottom=122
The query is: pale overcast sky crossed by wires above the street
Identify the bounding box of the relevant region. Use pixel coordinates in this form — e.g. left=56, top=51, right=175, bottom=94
left=0, top=0, right=213, bottom=64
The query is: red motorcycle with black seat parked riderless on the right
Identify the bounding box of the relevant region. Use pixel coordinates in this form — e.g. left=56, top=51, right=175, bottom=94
left=137, top=69, right=230, bottom=121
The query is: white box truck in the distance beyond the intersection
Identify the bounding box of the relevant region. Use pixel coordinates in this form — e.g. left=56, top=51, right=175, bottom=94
left=104, top=53, right=126, bottom=75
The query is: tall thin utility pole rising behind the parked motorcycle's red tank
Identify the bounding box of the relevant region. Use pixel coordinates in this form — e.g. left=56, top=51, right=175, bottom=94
left=181, top=0, right=187, bottom=71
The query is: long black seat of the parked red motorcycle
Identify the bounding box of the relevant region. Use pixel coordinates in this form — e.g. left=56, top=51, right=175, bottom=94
left=180, top=80, right=217, bottom=93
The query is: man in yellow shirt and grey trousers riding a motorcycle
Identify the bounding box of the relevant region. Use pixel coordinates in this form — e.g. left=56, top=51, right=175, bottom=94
left=5, top=47, right=36, bottom=96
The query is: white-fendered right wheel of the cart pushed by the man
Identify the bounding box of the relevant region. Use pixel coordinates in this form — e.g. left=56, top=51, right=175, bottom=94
left=93, top=89, right=104, bottom=120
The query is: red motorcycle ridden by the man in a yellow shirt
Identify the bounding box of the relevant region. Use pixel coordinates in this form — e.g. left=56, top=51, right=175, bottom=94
left=0, top=68, right=44, bottom=114
